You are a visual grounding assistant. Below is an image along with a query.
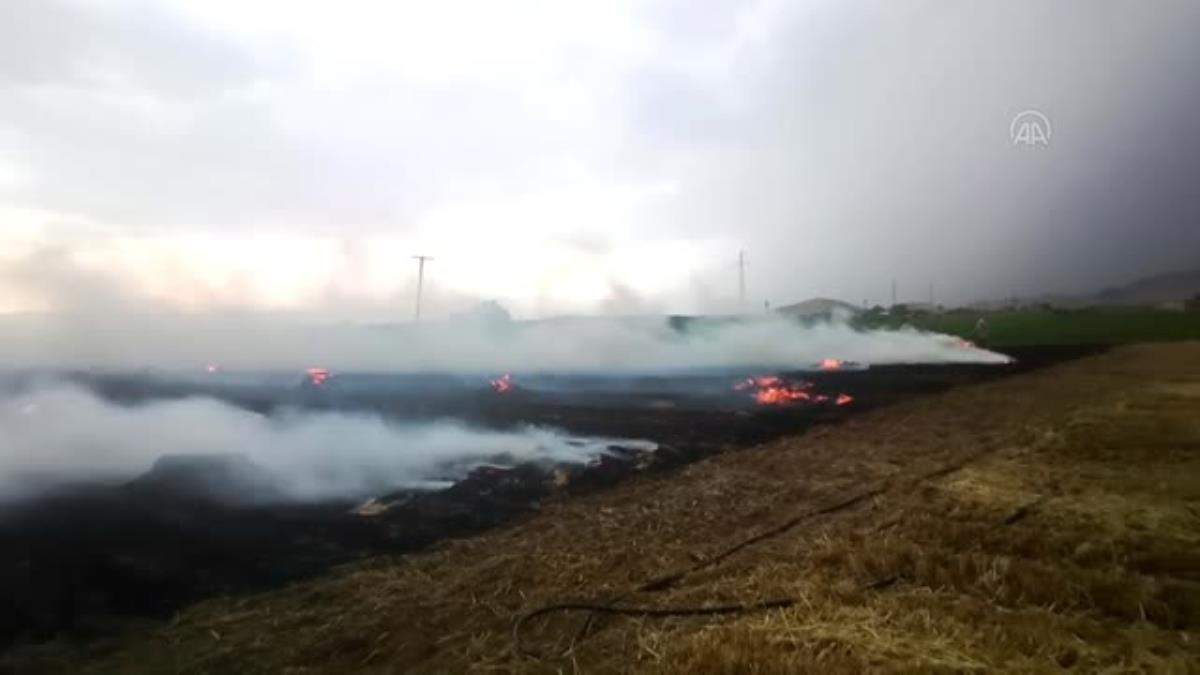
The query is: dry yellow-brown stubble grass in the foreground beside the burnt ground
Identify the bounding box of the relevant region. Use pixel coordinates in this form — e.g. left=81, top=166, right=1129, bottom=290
left=14, top=344, right=1200, bottom=673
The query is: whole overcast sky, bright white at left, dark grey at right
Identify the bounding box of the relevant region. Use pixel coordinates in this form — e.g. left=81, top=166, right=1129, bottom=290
left=0, top=0, right=1200, bottom=319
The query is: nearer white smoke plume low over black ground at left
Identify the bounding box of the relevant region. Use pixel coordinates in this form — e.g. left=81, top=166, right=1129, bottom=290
left=0, top=384, right=648, bottom=501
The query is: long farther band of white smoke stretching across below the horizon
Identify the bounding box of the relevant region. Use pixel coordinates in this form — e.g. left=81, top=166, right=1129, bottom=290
left=0, top=316, right=1007, bottom=372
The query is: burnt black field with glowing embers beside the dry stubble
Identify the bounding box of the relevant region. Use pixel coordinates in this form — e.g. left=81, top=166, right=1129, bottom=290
left=0, top=347, right=1096, bottom=643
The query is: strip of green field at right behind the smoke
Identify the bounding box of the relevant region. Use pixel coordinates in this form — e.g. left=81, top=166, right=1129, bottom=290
left=866, top=307, right=1200, bottom=347
